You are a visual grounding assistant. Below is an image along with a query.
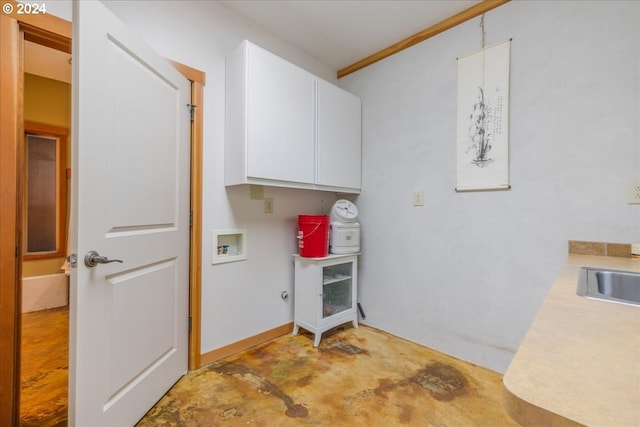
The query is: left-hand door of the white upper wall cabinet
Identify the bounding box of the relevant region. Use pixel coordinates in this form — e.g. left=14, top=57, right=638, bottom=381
left=246, top=44, right=314, bottom=183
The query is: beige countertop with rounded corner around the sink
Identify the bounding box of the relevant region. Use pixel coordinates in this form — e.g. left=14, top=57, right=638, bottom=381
left=503, top=255, right=640, bottom=427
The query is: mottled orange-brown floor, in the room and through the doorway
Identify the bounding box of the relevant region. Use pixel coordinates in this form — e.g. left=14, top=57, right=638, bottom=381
left=21, top=309, right=517, bottom=427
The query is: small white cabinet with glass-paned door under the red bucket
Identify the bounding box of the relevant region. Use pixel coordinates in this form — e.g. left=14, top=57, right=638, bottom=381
left=293, top=254, right=358, bottom=347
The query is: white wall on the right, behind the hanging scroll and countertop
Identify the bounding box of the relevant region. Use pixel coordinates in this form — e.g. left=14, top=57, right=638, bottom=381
left=340, top=1, right=640, bottom=371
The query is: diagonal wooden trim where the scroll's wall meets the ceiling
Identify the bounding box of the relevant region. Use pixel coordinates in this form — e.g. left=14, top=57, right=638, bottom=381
left=338, top=0, right=509, bottom=79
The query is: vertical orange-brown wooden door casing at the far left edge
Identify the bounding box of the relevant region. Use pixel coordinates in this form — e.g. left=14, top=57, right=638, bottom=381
left=0, top=15, right=22, bottom=426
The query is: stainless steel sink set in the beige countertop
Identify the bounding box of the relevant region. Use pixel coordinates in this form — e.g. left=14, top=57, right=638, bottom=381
left=577, top=267, right=640, bottom=306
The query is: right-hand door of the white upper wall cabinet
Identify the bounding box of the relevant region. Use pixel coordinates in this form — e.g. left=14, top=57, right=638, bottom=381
left=316, top=80, right=362, bottom=189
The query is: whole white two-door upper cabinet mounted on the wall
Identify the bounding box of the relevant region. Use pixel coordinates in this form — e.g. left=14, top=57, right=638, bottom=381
left=225, top=41, right=361, bottom=193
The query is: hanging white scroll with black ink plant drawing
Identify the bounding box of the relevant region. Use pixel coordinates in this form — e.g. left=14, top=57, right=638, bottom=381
left=456, top=40, right=511, bottom=191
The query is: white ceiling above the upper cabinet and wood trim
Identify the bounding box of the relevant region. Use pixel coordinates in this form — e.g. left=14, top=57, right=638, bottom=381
left=220, top=0, right=481, bottom=70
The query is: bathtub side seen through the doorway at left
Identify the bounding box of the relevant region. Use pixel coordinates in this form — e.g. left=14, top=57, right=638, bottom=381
left=22, top=273, right=69, bottom=313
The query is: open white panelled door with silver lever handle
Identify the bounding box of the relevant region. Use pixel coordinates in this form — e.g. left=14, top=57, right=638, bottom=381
left=69, top=1, right=190, bottom=427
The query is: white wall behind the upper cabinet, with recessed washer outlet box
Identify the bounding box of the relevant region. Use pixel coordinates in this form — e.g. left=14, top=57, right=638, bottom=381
left=47, top=0, right=344, bottom=353
